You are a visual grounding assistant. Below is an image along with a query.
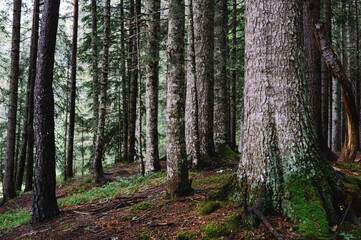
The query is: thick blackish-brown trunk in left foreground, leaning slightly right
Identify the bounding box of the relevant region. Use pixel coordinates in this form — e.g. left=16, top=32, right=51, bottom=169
left=31, top=0, right=60, bottom=223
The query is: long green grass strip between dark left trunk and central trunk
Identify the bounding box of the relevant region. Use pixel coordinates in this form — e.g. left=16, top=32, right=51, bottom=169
left=58, top=173, right=167, bottom=208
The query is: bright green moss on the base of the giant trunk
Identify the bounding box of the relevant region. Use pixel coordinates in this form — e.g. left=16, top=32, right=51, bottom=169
left=285, top=178, right=329, bottom=239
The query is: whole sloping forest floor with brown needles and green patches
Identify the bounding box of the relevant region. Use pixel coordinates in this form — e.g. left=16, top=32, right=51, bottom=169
left=0, top=153, right=361, bottom=240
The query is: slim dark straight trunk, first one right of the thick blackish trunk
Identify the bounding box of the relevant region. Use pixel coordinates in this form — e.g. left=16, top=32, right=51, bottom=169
left=66, top=0, right=78, bottom=178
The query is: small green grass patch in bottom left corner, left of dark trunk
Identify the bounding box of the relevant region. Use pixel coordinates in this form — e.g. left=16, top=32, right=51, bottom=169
left=0, top=208, right=31, bottom=231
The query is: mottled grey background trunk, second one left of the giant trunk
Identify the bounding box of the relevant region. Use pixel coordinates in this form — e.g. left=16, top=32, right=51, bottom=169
left=213, top=0, right=230, bottom=148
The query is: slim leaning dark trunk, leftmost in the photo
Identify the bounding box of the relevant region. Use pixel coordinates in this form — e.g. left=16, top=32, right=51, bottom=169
left=3, top=0, right=21, bottom=201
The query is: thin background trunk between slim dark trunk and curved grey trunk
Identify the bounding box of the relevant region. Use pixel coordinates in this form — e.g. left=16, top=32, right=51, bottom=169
left=92, top=0, right=98, bottom=157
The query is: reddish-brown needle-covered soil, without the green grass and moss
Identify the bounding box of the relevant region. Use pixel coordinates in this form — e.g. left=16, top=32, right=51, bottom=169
left=0, top=159, right=358, bottom=240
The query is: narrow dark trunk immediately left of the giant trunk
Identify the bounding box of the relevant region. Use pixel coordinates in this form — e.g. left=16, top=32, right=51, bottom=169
left=229, top=0, right=237, bottom=150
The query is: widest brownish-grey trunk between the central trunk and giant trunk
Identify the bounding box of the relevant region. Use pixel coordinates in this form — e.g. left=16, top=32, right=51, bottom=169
left=193, top=0, right=215, bottom=157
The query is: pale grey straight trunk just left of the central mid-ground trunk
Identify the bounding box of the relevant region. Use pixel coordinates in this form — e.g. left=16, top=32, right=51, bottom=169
left=145, top=0, right=160, bottom=173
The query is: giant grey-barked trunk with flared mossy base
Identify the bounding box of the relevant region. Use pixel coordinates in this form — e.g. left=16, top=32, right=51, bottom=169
left=238, top=0, right=339, bottom=236
